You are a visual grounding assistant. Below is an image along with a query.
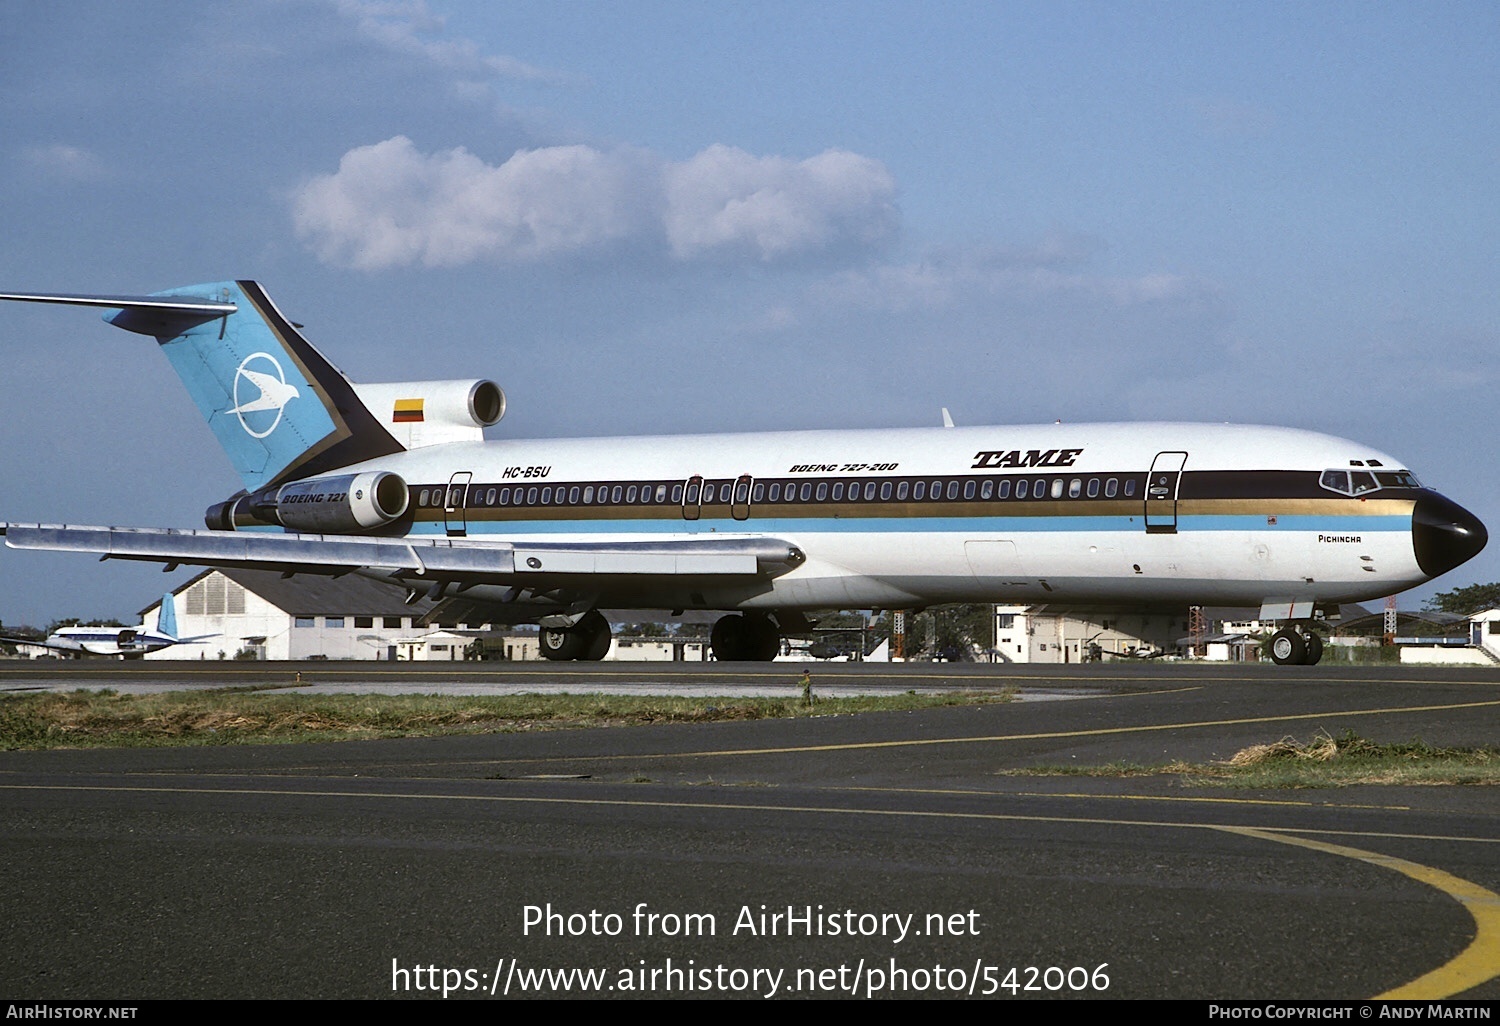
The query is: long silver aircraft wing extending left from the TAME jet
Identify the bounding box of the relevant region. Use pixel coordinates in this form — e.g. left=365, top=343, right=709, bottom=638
left=0, top=524, right=806, bottom=585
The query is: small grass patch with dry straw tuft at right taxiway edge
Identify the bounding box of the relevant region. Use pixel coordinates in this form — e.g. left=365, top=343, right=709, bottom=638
left=1002, top=731, right=1500, bottom=789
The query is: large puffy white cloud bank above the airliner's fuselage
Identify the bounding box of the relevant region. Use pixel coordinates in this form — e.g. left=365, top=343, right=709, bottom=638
left=293, top=135, right=897, bottom=270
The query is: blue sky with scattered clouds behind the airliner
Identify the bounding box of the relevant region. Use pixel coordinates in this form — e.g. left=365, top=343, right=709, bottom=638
left=0, top=0, right=1500, bottom=626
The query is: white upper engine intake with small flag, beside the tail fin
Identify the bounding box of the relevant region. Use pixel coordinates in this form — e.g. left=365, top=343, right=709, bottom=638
left=354, top=378, right=506, bottom=449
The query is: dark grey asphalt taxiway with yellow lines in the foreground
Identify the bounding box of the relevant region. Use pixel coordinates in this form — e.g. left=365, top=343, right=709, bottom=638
left=0, top=665, right=1500, bottom=1001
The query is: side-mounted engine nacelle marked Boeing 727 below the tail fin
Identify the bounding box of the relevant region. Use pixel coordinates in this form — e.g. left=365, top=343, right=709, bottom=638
left=204, top=471, right=410, bottom=534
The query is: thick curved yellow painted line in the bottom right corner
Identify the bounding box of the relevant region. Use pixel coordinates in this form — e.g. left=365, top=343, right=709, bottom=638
left=1218, top=827, right=1500, bottom=1001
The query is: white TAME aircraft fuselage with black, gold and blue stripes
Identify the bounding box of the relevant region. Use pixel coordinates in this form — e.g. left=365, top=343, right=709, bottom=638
left=307, top=423, right=1464, bottom=611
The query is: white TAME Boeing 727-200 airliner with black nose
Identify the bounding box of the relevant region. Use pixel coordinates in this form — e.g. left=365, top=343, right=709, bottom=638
left=0, top=281, right=1488, bottom=663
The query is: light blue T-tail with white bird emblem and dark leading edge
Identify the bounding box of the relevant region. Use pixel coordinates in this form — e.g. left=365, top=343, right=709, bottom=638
left=0, top=281, right=404, bottom=492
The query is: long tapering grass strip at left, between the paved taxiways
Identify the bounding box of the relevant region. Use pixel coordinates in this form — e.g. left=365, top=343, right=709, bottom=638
left=0, top=689, right=1011, bottom=750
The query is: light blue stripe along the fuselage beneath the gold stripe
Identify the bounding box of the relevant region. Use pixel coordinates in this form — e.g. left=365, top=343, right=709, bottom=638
left=411, top=513, right=1412, bottom=537
